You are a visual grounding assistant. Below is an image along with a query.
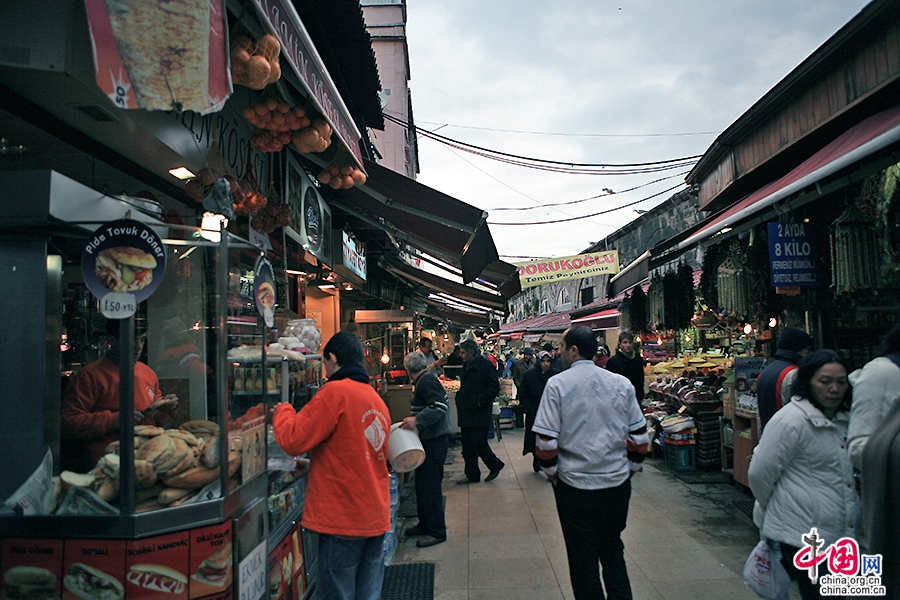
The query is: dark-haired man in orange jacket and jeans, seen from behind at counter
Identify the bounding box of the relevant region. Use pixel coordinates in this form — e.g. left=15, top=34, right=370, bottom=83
left=272, top=331, right=391, bottom=600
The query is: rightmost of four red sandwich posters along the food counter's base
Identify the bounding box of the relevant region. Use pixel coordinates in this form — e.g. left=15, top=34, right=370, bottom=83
left=188, top=521, right=234, bottom=600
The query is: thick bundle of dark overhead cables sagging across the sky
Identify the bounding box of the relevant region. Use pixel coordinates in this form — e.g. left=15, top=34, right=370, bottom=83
left=384, top=114, right=702, bottom=175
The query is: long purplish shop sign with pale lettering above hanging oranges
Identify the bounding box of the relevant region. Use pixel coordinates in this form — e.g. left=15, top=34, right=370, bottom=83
left=253, top=0, right=363, bottom=169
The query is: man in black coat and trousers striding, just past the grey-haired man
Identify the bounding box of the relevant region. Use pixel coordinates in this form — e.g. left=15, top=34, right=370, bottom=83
left=456, top=340, right=506, bottom=484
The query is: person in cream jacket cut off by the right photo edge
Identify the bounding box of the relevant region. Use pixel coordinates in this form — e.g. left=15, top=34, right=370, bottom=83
left=847, top=324, right=900, bottom=470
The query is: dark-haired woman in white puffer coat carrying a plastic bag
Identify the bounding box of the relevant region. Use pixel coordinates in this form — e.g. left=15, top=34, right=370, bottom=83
left=749, top=350, right=859, bottom=600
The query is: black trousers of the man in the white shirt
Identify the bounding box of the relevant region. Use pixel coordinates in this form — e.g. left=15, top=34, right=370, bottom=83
left=553, top=480, right=631, bottom=600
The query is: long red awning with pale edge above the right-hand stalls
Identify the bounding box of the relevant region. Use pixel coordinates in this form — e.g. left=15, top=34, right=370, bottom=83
left=652, top=106, right=900, bottom=262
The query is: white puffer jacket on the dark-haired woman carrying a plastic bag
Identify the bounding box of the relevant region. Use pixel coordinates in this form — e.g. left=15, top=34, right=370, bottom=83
left=749, top=396, right=859, bottom=547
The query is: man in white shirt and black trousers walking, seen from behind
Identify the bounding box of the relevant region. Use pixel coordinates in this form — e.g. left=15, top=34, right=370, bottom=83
left=532, top=326, right=649, bottom=600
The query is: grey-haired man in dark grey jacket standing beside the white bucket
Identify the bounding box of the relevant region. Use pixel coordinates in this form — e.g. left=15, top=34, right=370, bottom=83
left=400, top=352, right=450, bottom=548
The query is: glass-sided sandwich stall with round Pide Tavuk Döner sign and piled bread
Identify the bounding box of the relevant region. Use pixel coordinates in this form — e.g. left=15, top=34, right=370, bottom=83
left=0, top=171, right=322, bottom=598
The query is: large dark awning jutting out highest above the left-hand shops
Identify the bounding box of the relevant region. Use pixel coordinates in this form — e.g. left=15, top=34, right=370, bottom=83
left=330, top=160, right=521, bottom=290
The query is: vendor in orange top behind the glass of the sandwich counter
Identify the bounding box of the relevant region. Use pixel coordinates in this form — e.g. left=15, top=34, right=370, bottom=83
left=60, top=320, right=178, bottom=473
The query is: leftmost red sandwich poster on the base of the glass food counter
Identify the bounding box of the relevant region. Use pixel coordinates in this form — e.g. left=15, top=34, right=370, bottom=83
left=0, top=539, right=63, bottom=598
